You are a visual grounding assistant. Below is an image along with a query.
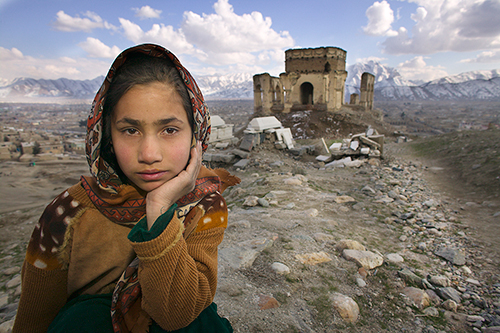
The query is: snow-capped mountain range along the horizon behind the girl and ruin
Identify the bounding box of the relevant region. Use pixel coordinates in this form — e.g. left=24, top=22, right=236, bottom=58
left=0, top=61, right=500, bottom=102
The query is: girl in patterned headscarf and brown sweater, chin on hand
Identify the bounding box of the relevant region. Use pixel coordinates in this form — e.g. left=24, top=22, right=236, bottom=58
left=13, top=44, right=239, bottom=332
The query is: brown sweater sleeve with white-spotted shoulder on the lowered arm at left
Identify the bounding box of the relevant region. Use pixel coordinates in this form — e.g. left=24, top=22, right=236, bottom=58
left=13, top=191, right=83, bottom=332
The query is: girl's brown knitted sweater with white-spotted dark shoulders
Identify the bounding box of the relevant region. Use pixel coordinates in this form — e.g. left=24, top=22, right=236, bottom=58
left=13, top=174, right=227, bottom=333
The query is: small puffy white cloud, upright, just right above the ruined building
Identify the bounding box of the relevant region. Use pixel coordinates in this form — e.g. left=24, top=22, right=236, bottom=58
left=363, top=0, right=397, bottom=36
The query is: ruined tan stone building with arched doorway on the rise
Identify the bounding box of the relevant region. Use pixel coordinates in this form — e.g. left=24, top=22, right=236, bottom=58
left=253, top=47, right=375, bottom=114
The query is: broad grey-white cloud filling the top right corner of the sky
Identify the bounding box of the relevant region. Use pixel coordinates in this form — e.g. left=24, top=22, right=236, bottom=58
left=382, top=0, right=500, bottom=54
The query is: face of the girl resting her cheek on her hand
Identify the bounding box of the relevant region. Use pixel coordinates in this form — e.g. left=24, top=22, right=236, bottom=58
left=111, top=82, right=193, bottom=192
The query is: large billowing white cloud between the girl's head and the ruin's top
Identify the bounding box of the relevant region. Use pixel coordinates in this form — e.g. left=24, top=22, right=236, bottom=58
left=182, top=0, right=294, bottom=56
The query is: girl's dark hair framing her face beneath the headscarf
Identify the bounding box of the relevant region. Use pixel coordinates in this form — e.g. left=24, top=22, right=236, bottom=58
left=101, top=53, right=194, bottom=181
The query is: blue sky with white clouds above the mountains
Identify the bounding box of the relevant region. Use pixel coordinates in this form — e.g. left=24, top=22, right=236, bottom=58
left=0, top=0, right=500, bottom=83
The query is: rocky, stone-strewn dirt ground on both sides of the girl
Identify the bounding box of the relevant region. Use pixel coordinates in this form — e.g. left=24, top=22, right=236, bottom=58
left=0, top=130, right=500, bottom=332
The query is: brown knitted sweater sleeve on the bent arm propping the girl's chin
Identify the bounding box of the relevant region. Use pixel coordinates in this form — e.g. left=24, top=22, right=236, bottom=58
left=132, top=193, right=228, bottom=331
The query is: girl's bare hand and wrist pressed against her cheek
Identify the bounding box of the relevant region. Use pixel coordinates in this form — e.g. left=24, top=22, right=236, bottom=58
left=146, top=142, right=202, bottom=230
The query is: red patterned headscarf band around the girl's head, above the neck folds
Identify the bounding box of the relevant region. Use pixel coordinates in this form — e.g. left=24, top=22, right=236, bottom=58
left=85, top=44, right=210, bottom=195
